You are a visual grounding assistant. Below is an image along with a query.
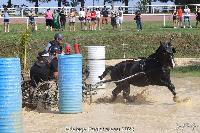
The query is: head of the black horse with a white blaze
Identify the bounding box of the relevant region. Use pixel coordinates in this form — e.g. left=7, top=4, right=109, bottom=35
left=156, top=42, right=176, bottom=68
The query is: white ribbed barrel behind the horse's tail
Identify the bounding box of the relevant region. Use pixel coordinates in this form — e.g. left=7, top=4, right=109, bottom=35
left=87, top=46, right=105, bottom=88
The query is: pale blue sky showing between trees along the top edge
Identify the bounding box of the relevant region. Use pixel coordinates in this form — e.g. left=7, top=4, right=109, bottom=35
left=0, top=0, right=173, bottom=7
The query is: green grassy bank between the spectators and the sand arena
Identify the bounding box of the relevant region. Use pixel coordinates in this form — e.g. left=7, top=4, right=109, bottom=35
left=0, top=22, right=200, bottom=69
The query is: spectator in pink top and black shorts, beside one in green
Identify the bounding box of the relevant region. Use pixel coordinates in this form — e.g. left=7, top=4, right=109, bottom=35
left=45, top=8, right=53, bottom=31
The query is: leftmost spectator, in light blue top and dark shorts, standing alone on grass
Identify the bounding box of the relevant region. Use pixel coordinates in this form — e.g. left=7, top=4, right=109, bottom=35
left=2, top=7, right=10, bottom=32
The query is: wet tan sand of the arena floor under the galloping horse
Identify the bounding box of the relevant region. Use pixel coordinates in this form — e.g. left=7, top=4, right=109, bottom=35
left=23, top=77, right=200, bottom=133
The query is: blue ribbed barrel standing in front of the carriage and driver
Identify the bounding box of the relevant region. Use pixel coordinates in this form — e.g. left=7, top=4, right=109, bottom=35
left=58, top=54, right=82, bottom=113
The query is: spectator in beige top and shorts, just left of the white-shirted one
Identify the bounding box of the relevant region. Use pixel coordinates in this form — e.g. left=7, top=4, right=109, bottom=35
left=69, top=8, right=76, bottom=31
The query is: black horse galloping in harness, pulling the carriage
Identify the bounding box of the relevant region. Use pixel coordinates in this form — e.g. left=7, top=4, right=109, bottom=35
left=99, top=42, right=176, bottom=101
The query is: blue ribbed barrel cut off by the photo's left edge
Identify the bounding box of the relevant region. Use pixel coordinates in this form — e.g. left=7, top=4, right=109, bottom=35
left=0, top=58, right=22, bottom=133
